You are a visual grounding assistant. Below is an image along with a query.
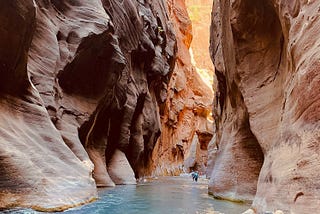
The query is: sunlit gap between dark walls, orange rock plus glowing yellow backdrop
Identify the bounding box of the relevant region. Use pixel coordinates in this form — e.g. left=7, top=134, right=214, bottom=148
left=153, top=0, right=215, bottom=179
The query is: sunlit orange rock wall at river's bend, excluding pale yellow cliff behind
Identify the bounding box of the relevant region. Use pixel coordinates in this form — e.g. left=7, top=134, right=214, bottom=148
left=152, top=0, right=213, bottom=175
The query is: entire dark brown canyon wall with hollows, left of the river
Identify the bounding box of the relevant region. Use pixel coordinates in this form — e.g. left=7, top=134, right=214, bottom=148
left=0, top=0, right=176, bottom=211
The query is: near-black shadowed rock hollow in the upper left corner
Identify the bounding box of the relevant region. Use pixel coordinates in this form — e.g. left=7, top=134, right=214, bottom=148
left=0, top=2, right=36, bottom=94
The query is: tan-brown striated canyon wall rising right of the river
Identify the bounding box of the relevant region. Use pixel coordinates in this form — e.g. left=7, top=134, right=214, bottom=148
left=209, top=0, right=320, bottom=213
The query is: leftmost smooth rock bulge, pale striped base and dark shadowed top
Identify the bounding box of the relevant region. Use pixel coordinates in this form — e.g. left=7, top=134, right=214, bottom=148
left=0, top=1, right=101, bottom=211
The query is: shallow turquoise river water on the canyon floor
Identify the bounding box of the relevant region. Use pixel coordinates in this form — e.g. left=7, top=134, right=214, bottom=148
left=4, top=177, right=248, bottom=214
